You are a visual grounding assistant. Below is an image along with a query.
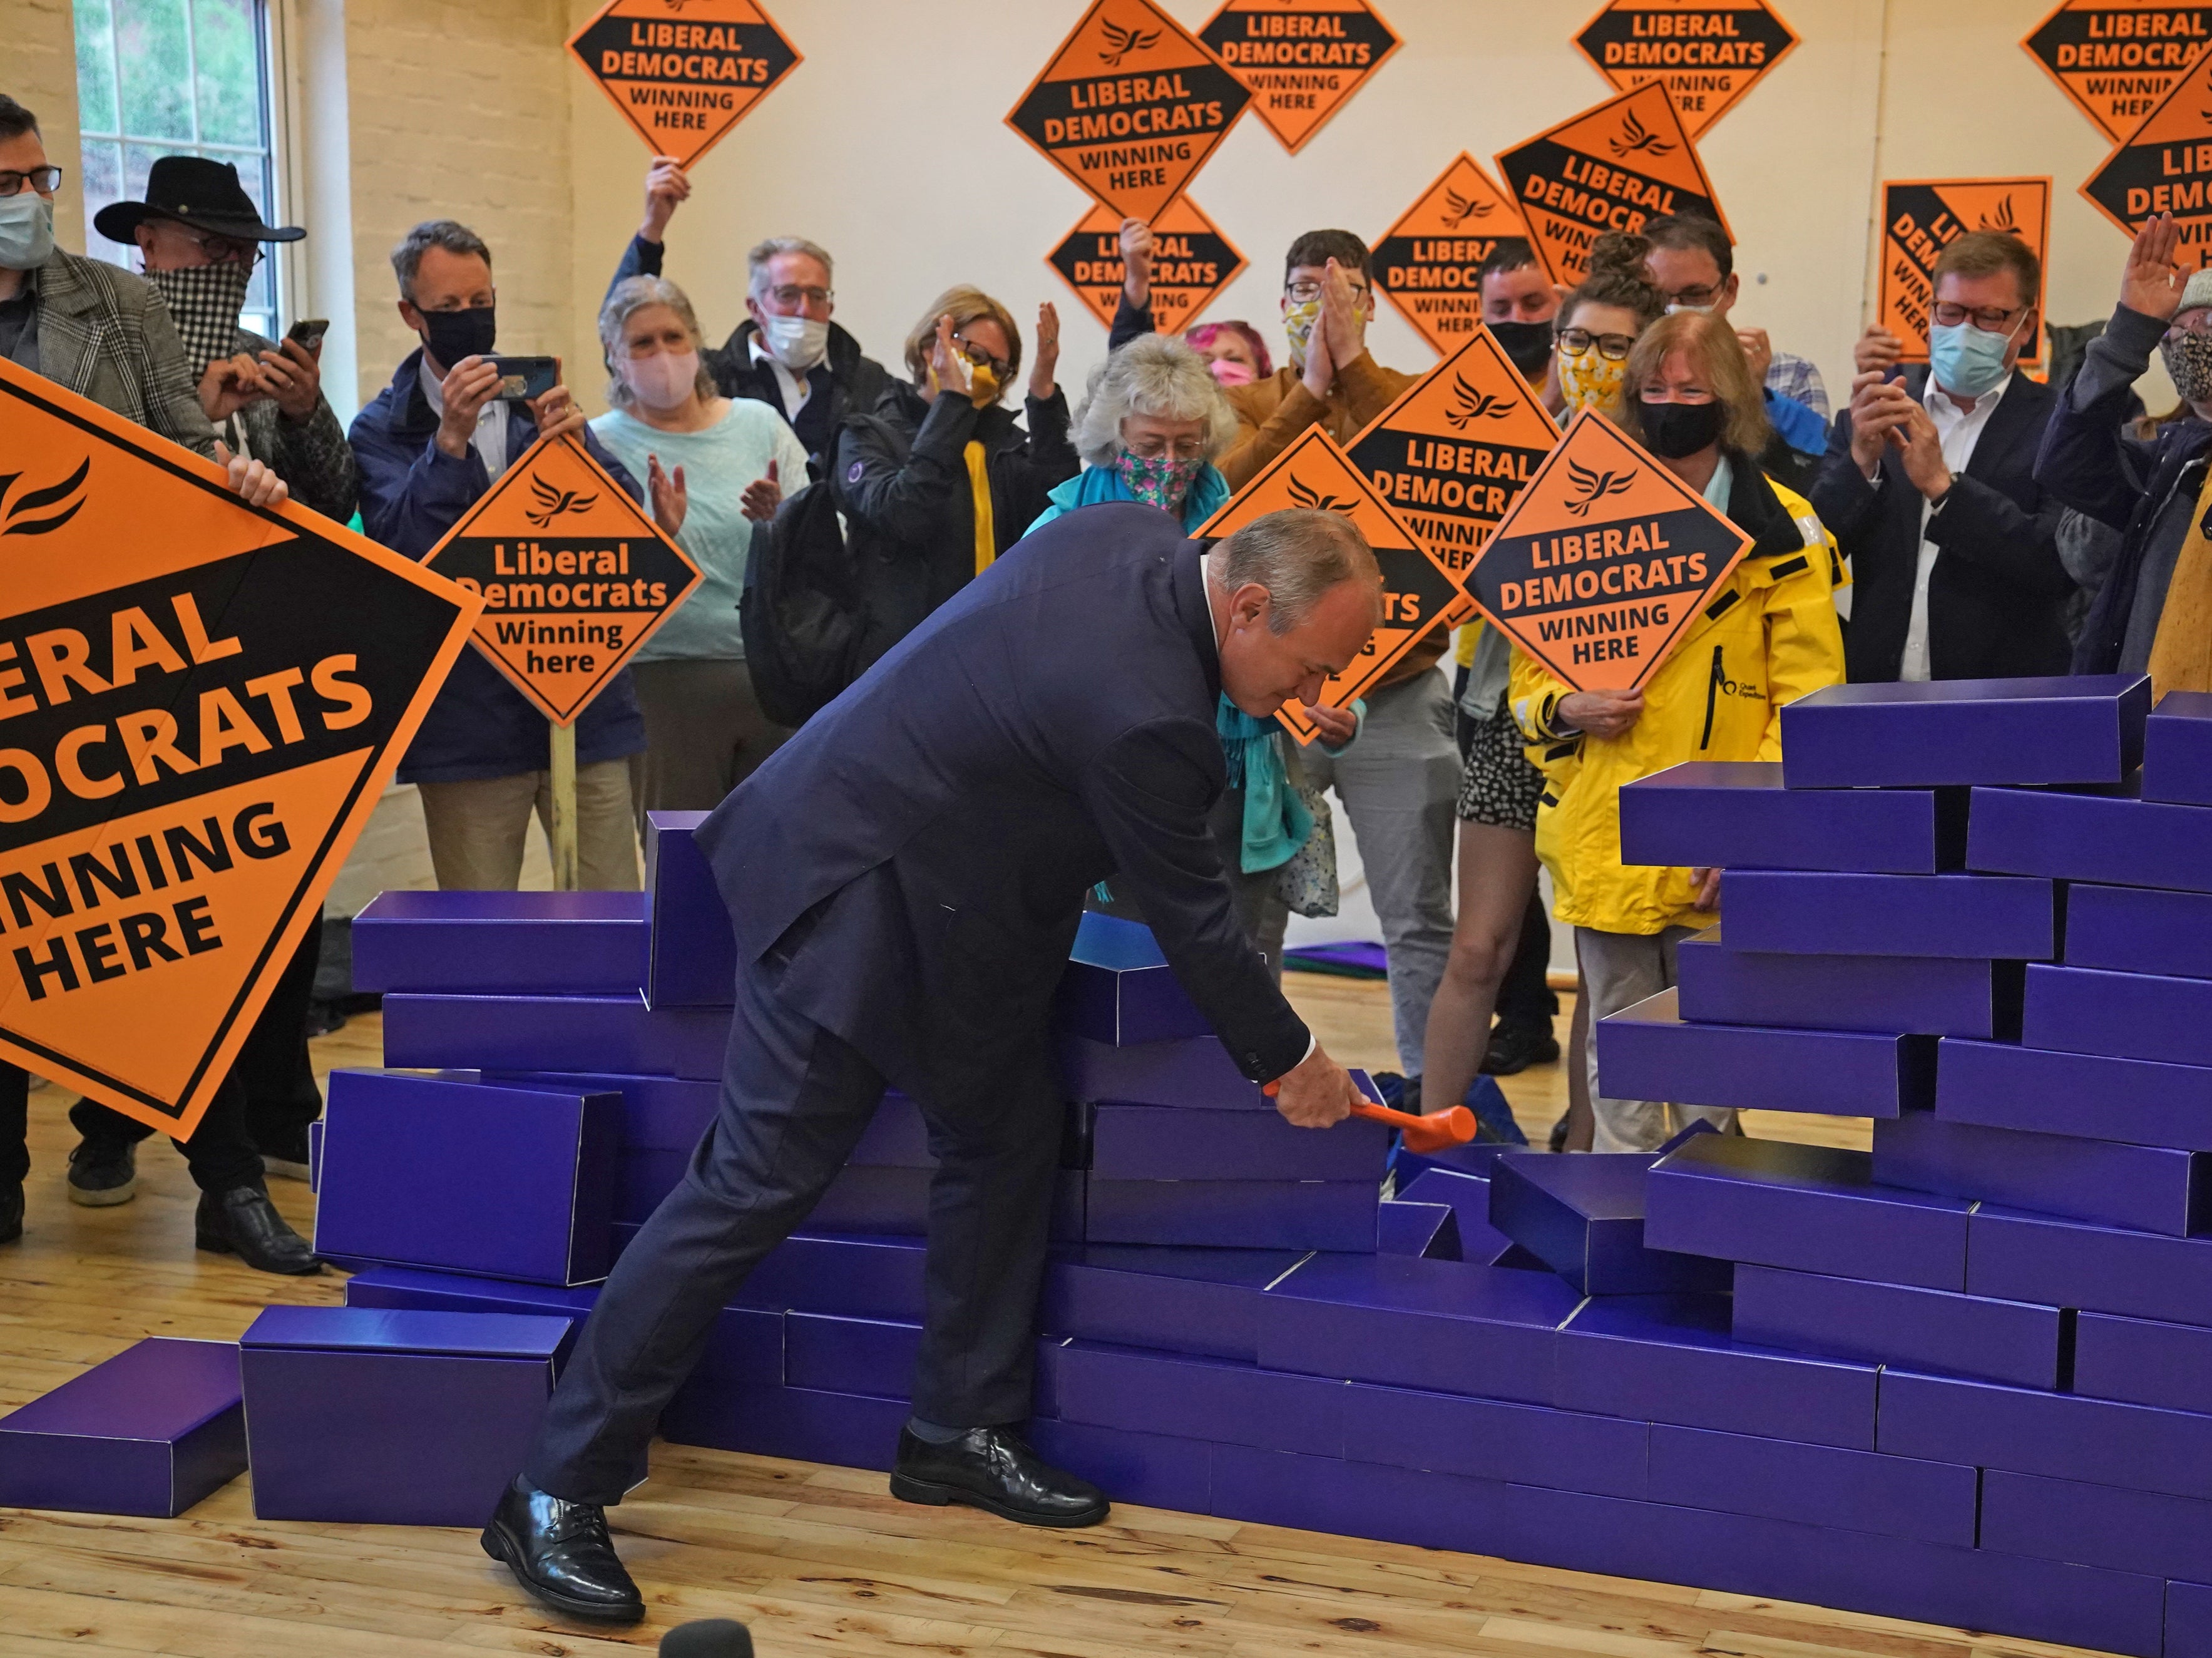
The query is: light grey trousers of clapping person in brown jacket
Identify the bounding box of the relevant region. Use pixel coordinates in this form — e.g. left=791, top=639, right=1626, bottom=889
left=1298, top=670, right=1460, bottom=1077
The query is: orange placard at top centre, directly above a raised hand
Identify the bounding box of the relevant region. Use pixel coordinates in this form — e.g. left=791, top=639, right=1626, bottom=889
left=1006, top=0, right=1252, bottom=219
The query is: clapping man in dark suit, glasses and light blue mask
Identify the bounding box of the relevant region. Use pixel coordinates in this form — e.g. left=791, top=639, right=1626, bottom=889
left=1811, top=230, right=2072, bottom=681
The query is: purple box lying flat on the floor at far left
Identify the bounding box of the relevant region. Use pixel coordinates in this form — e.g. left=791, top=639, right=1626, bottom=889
left=0, top=1338, right=245, bottom=1518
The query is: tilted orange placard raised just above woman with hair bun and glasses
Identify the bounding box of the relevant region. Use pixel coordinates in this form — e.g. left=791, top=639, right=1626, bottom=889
left=1498, top=82, right=1736, bottom=285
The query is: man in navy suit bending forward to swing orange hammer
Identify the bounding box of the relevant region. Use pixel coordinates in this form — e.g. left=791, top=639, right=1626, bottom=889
left=484, top=504, right=1380, bottom=1620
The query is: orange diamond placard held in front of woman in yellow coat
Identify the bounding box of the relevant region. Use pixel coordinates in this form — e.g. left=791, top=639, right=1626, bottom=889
left=1467, top=409, right=1752, bottom=690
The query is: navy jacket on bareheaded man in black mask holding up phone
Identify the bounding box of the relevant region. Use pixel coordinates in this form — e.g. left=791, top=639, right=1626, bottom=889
left=347, top=347, right=646, bottom=782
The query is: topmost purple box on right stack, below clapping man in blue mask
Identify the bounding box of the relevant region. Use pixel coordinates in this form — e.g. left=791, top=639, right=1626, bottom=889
left=1783, top=674, right=2150, bottom=789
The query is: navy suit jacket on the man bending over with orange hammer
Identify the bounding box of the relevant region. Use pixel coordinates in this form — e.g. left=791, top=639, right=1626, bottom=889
left=699, top=502, right=1308, bottom=1098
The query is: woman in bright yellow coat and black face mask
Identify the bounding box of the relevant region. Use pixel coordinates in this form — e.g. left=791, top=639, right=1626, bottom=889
left=1511, top=312, right=1843, bottom=1152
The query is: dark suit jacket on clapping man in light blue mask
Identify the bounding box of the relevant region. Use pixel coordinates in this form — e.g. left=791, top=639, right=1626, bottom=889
left=1811, top=369, right=2072, bottom=681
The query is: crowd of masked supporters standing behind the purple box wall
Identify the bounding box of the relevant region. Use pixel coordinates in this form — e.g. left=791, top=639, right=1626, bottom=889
left=0, top=74, right=2212, bottom=1271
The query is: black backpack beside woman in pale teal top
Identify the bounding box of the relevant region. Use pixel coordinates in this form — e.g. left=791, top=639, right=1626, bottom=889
left=739, top=482, right=867, bottom=725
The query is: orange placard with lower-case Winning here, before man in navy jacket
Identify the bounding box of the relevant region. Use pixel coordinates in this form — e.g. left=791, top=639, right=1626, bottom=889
left=422, top=436, right=699, bottom=725
